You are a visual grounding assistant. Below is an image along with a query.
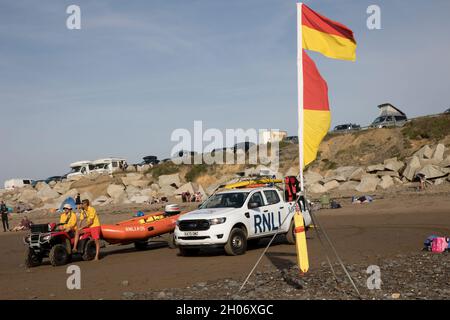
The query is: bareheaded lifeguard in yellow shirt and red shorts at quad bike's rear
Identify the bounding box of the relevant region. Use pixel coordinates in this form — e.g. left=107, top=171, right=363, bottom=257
left=72, top=199, right=101, bottom=260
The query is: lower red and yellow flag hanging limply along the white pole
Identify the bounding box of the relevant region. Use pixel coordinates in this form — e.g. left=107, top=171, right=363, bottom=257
left=303, top=50, right=331, bottom=166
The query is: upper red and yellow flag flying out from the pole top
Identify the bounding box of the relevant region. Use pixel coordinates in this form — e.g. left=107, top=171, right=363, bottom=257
left=301, top=4, right=356, bottom=61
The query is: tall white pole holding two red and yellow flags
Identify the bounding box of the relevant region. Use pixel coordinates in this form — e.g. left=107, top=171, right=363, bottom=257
left=297, top=2, right=305, bottom=192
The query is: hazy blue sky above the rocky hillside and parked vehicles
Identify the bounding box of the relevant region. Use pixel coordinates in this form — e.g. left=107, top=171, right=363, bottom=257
left=0, top=0, right=450, bottom=181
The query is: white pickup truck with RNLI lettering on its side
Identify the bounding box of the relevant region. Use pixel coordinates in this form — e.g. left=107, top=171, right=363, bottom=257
left=175, top=187, right=311, bottom=255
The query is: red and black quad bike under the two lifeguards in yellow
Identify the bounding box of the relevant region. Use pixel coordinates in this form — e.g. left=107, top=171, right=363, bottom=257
left=24, top=223, right=96, bottom=268
